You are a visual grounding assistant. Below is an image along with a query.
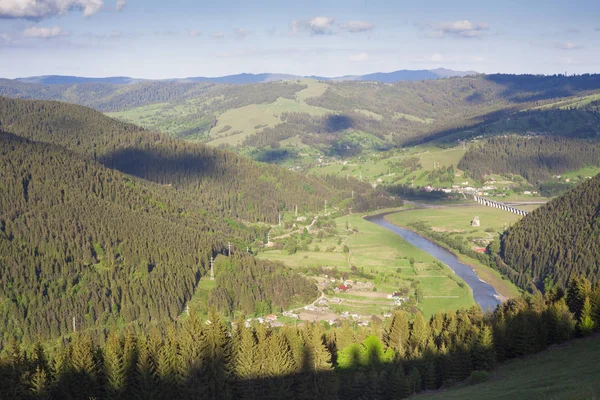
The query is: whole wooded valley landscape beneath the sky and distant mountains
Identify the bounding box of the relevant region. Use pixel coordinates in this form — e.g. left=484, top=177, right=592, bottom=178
left=0, top=75, right=600, bottom=399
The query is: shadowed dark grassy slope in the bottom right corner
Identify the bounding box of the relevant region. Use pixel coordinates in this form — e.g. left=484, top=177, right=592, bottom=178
left=413, top=335, right=600, bottom=400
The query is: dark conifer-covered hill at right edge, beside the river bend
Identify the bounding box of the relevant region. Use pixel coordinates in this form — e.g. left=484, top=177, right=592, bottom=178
left=501, top=175, right=600, bottom=289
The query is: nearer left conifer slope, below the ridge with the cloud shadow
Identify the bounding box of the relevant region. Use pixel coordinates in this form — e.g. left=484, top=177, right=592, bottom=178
left=0, top=133, right=315, bottom=346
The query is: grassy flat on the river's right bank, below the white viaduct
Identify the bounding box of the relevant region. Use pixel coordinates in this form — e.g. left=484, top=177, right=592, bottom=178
left=387, top=205, right=538, bottom=297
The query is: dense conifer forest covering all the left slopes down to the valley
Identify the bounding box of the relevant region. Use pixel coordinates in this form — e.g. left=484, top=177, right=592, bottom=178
left=0, top=98, right=401, bottom=345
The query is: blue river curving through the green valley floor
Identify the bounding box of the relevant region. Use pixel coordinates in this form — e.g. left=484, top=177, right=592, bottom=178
left=366, top=215, right=500, bottom=310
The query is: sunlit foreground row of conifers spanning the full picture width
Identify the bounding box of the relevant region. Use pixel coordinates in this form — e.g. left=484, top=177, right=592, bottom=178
left=0, top=280, right=600, bottom=400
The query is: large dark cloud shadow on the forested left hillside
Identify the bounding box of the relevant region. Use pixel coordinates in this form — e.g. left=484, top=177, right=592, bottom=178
left=99, top=147, right=221, bottom=184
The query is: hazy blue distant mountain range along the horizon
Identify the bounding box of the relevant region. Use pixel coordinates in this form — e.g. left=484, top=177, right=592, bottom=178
left=15, top=68, right=477, bottom=85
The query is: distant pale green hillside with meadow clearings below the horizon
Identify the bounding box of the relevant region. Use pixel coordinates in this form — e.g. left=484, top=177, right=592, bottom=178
left=0, top=75, right=600, bottom=161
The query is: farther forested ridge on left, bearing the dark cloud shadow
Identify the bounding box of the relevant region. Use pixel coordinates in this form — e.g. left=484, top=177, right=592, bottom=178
left=0, top=97, right=394, bottom=222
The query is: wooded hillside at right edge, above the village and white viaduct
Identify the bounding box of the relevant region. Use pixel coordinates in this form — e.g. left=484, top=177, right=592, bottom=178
left=458, top=136, right=600, bottom=184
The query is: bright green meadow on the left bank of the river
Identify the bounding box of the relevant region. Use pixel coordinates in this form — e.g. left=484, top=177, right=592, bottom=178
left=258, top=215, right=475, bottom=317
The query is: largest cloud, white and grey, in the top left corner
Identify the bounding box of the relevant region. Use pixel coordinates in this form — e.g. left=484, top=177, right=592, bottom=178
left=0, top=0, right=104, bottom=19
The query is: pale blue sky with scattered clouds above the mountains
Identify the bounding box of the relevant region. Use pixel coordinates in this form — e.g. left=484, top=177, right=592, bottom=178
left=0, top=0, right=600, bottom=79
